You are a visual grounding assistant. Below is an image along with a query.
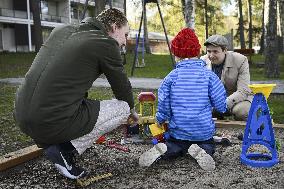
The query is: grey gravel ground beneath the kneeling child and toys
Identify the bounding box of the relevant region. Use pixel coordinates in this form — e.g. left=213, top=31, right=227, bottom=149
left=0, top=128, right=284, bottom=189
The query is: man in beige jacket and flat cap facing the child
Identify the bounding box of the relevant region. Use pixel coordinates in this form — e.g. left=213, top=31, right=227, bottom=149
left=201, top=35, right=253, bottom=121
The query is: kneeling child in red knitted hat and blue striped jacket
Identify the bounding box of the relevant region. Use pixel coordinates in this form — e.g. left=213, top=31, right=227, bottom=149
left=139, top=28, right=226, bottom=170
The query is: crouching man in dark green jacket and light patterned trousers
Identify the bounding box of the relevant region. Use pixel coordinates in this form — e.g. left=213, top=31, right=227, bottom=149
left=15, top=9, right=138, bottom=179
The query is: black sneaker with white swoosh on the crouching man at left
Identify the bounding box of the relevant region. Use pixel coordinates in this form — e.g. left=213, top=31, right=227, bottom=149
left=44, top=145, right=85, bottom=179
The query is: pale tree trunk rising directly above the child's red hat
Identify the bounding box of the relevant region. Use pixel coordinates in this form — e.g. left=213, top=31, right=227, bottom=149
left=183, top=0, right=195, bottom=29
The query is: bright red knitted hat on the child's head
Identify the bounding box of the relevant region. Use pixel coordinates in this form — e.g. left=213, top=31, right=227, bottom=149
left=171, top=28, right=201, bottom=58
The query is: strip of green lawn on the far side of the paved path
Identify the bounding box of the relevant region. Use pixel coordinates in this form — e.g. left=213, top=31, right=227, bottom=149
left=0, top=53, right=284, bottom=81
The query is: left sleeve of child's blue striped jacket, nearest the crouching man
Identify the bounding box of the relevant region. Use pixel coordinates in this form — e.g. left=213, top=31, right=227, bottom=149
left=156, top=72, right=173, bottom=124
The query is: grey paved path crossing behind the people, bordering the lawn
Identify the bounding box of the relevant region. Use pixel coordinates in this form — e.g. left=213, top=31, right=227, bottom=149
left=0, top=77, right=284, bottom=94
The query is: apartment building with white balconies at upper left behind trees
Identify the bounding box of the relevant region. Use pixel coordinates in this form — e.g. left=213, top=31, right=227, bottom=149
left=0, top=0, right=124, bottom=52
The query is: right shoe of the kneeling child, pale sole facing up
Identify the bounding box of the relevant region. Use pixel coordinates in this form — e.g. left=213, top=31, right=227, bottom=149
left=188, top=144, right=215, bottom=171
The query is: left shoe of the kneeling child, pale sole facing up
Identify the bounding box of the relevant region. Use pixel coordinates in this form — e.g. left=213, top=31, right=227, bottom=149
left=139, top=143, right=167, bottom=167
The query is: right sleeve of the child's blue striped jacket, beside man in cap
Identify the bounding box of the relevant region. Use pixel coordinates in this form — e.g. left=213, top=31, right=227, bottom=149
left=209, top=72, right=227, bottom=113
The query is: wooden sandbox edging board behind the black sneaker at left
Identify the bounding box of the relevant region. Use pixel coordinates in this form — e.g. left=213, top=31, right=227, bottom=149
left=0, top=145, right=43, bottom=171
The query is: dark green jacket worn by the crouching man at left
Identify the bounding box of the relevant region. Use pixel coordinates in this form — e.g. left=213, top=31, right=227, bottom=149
left=15, top=18, right=134, bottom=147
